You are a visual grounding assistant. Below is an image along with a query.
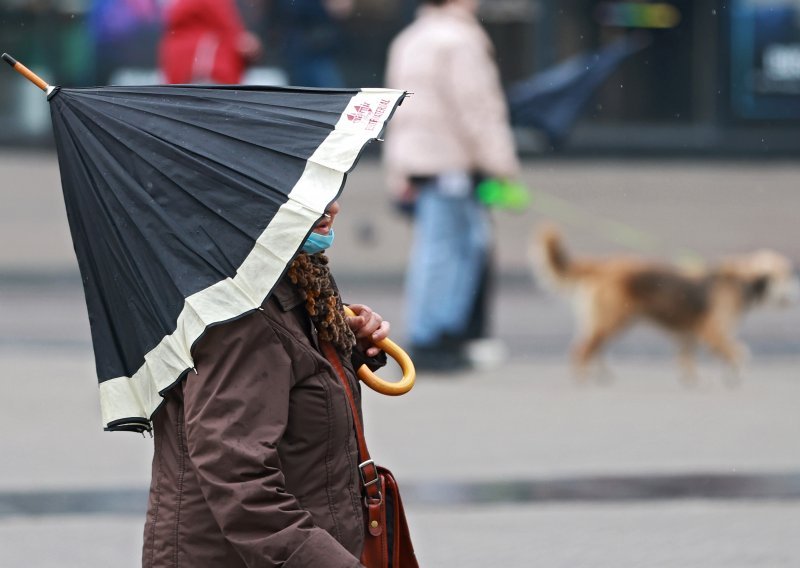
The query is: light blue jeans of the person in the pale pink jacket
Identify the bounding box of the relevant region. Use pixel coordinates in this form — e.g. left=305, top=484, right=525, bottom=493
left=406, top=182, right=491, bottom=347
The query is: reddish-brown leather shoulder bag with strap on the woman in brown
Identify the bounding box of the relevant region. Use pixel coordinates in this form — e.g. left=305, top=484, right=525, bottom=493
left=321, top=342, right=419, bottom=568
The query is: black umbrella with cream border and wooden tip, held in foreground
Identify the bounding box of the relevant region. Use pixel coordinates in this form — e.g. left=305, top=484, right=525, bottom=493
left=3, top=54, right=405, bottom=432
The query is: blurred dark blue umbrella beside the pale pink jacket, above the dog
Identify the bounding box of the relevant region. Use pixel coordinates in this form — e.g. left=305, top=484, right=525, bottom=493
left=507, top=34, right=651, bottom=147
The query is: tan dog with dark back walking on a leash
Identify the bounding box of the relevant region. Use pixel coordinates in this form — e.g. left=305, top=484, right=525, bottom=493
left=531, top=225, right=800, bottom=381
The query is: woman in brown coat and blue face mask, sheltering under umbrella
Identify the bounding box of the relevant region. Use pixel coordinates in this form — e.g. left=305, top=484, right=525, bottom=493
left=143, top=202, right=389, bottom=568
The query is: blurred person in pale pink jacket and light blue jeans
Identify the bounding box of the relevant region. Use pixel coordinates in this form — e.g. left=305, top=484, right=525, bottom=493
left=384, top=0, right=519, bottom=370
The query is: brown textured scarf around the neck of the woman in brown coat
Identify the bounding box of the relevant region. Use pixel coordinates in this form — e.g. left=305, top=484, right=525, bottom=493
left=287, top=252, right=356, bottom=357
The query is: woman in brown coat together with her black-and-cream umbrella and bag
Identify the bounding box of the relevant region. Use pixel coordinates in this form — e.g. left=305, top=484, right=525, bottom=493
left=3, top=54, right=417, bottom=568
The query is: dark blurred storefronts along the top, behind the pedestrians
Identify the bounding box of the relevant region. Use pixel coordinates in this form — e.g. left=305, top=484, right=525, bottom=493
left=0, top=0, right=800, bottom=155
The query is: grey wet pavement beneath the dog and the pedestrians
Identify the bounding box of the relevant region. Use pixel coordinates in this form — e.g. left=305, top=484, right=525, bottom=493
left=0, top=152, right=800, bottom=568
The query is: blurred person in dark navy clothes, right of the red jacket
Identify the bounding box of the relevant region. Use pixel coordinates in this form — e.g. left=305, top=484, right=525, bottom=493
left=273, top=0, right=355, bottom=88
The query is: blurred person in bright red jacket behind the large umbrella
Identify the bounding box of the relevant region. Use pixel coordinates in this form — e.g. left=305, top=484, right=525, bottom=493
left=159, top=0, right=261, bottom=84
